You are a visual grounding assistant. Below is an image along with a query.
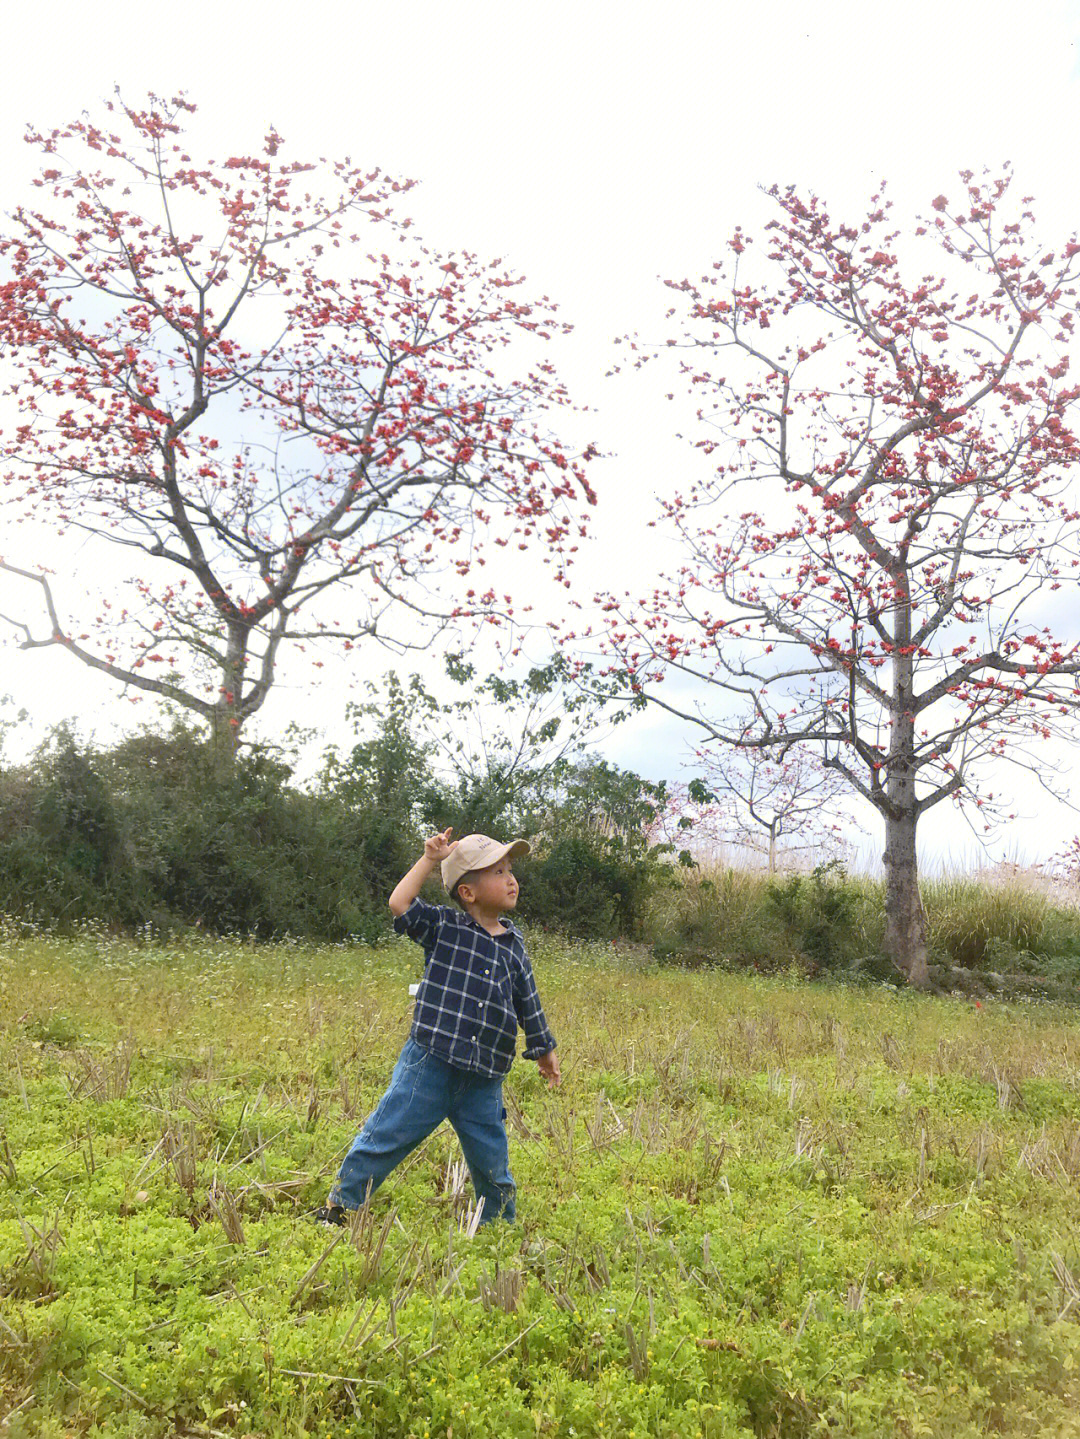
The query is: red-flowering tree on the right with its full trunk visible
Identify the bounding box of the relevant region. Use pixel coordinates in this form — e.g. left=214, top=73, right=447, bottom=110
left=604, top=173, right=1080, bottom=984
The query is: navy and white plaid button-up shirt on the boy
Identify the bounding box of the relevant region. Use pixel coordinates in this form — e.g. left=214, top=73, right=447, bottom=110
left=394, top=899, right=555, bottom=1076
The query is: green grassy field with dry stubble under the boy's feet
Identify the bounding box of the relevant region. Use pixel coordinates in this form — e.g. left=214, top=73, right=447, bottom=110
left=0, top=934, right=1080, bottom=1439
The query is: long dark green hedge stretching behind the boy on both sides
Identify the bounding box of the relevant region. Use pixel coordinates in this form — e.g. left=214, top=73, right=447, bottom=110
left=0, top=715, right=666, bottom=940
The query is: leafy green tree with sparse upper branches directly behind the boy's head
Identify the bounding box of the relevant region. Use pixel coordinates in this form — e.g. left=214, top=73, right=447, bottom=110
left=336, top=655, right=672, bottom=937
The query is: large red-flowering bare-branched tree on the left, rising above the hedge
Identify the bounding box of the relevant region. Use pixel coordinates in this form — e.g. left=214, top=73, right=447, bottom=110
left=0, top=96, right=594, bottom=754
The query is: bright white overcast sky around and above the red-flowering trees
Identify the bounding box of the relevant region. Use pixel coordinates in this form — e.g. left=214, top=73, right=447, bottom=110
left=0, top=0, right=1080, bottom=861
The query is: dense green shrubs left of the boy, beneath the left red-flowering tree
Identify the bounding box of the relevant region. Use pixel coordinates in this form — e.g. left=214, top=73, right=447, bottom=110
left=0, top=725, right=396, bottom=940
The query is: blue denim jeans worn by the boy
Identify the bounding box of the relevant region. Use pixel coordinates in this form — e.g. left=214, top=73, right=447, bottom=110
left=329, top=1039, right=515, bottom=1225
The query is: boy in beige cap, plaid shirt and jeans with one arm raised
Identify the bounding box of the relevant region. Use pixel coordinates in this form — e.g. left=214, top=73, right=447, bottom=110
left=315, top=829, right=561, bottom=1225
